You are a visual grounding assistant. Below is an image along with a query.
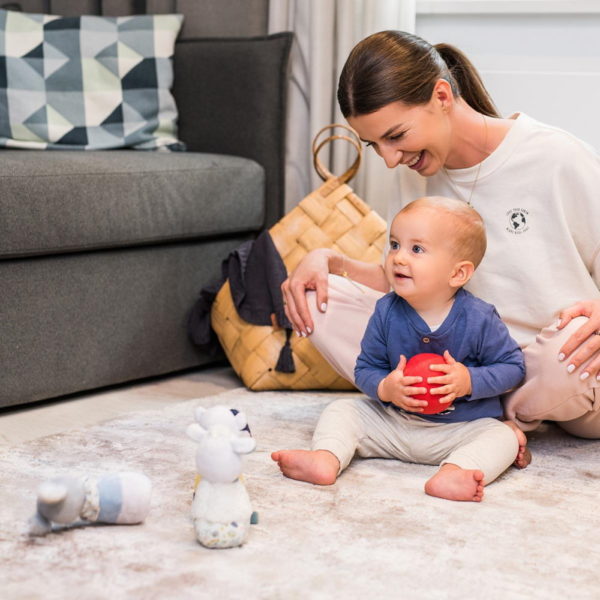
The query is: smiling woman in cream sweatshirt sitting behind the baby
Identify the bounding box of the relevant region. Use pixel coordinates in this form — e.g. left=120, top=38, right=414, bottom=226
left=282, top=31, right=600, bottom=438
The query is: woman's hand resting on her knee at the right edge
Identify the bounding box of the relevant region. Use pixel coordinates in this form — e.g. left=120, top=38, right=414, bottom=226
left=558, top=300, right=600, bottom=379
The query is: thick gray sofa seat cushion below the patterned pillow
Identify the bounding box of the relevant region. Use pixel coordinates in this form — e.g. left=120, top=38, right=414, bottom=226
left=0, top=150, right=265, bottom=258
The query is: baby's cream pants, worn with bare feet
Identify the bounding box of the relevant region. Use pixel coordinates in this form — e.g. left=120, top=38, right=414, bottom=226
left=312, top=398, right=519, bottom=484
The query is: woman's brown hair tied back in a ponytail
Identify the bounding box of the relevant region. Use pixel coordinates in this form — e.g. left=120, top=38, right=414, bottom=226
left=338, top=31, right=500, bottom=117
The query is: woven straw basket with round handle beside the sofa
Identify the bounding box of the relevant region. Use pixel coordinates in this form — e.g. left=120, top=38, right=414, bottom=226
left=211, top=124, right=386, bottom=390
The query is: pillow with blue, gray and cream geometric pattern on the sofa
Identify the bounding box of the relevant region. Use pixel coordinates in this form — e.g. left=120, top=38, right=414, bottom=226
left=0, top=10, right=185, bottom=150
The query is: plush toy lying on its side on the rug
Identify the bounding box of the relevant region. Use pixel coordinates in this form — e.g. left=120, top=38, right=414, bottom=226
left=29, top=472, right=152, bottom=536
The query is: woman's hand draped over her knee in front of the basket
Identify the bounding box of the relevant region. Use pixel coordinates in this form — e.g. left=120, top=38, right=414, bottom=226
left=281, top=248, right=334, bottom=337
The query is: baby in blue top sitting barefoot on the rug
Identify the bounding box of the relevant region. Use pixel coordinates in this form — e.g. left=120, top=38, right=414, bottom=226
left=271, top=197, right=528, bottom=502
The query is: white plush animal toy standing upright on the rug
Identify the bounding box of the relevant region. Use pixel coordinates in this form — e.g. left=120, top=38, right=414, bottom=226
left=187, top=407, right=256, bottom=548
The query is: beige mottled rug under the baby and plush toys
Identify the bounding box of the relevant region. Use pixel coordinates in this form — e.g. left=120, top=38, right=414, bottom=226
left=0, top=389, right=600, bottom=600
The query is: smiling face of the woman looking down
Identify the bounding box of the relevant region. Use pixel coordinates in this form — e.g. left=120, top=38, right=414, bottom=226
left=348, top=91, right=451, bottom=177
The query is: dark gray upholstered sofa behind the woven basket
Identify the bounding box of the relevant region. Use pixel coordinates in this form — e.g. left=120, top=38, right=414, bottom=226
left=0, top=0, right=291, bottom=406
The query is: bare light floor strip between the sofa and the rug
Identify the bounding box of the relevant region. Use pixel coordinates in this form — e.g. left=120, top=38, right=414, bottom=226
left=0, top=366, right=243, bottom=447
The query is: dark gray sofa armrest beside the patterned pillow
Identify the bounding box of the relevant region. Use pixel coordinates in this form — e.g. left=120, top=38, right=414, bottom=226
left=173, top=32, right=292, bottom=227
